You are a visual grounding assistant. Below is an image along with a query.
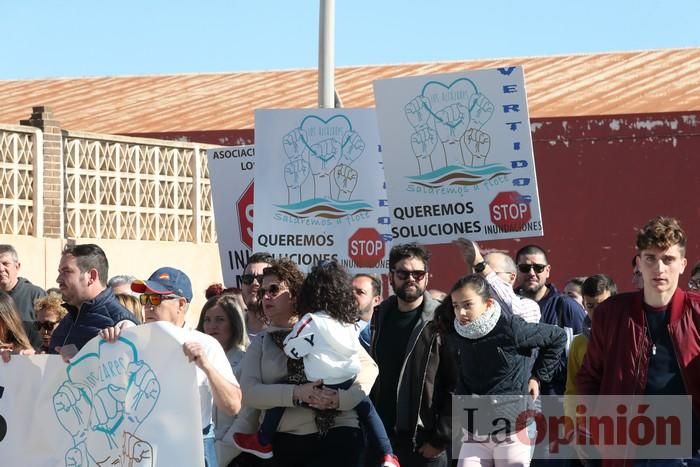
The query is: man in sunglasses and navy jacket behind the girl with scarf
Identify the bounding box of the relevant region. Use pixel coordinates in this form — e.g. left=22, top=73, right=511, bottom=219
left=515, top=245, right=586, bottom=395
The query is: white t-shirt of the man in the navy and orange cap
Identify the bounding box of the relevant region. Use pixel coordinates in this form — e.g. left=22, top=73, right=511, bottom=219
left=173, top=328, right=239, bottom=428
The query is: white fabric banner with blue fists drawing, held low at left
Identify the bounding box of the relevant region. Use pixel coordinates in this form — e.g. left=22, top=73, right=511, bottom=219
left=0, top=323, right=204, bottom=467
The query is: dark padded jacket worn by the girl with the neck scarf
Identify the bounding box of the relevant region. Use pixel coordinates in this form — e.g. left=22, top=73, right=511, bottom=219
left=448, top=314, right=566, bottom=433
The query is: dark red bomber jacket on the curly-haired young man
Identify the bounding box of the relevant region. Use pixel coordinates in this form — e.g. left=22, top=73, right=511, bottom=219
left=576, top=289, right=700, bottom=466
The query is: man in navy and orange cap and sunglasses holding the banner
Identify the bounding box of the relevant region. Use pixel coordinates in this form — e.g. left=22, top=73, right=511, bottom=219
left=100, top=267, right=241, bottom=467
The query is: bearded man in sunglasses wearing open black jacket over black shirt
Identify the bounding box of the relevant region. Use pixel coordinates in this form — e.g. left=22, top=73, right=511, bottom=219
left=370, top=243, right=451, bottom=467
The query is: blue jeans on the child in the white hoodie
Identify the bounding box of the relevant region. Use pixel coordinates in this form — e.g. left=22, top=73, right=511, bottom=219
left=258, top=378, right=394, bottom=454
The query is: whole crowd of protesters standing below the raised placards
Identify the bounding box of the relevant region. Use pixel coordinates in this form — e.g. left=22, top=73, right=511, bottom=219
left=0, top=217, right=700, bottom=467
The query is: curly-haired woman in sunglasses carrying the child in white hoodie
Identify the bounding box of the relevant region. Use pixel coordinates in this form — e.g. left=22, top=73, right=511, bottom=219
left=234, top=258, right=377, bottom=467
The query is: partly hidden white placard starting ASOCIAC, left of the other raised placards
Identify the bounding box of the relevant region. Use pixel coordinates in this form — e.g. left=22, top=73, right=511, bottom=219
left=207, top=146, right=255, bottom=287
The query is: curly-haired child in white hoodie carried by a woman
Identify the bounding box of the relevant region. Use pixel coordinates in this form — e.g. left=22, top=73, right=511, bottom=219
left=233, top=261, right=399, bottom=467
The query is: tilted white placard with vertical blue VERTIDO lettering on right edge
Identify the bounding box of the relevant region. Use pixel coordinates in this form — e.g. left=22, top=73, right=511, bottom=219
left=374, top=66, right=543, bottom=243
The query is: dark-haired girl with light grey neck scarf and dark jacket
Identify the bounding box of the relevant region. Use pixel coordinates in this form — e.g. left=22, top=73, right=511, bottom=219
left=435, top=274, right=566, bottom=467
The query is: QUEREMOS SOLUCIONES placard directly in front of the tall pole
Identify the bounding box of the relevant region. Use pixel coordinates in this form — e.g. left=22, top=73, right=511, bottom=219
left=253, top=109, right=391, bottom=273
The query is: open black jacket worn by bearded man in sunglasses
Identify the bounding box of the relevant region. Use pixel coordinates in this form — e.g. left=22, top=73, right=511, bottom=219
left=370, top=293, right=456, bottom=448
